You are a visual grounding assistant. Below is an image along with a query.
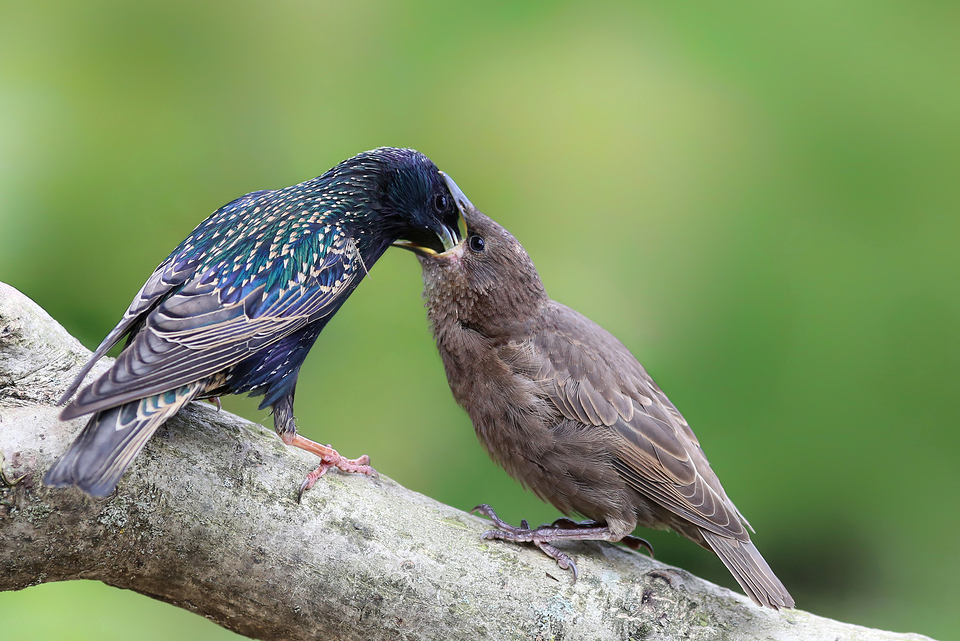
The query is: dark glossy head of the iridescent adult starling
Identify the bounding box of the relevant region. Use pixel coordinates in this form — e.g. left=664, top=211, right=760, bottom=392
left=336, top=147, right=462, bottom=254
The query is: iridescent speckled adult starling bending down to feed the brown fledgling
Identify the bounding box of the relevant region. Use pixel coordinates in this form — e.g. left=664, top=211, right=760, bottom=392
left=44, top=147, right=460, bottom=496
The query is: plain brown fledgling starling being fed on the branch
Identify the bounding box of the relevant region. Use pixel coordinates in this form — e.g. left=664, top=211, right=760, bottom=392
left=412, top=182, right=794, bottom=609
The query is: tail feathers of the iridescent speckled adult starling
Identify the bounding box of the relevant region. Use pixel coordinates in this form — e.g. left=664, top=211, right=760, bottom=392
left=43, top=381, right=205, bottom=497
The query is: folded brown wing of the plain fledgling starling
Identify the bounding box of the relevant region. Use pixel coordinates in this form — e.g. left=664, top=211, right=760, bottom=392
left=529, top=302, right=749, bottom=540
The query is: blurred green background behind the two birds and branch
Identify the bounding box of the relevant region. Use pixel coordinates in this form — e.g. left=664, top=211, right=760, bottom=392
left=0, top=0, right=960, bottom=639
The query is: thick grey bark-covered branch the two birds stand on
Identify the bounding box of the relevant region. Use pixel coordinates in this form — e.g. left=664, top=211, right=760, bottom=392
left=0, top=283, right=926, bottom=641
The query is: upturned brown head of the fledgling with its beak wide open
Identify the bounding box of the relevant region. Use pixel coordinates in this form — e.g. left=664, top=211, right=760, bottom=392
left=419, top=175, right=549, bottom=336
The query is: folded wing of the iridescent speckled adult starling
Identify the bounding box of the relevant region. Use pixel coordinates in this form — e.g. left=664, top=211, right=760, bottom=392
left=61, top=236, right=365, bottom=420
